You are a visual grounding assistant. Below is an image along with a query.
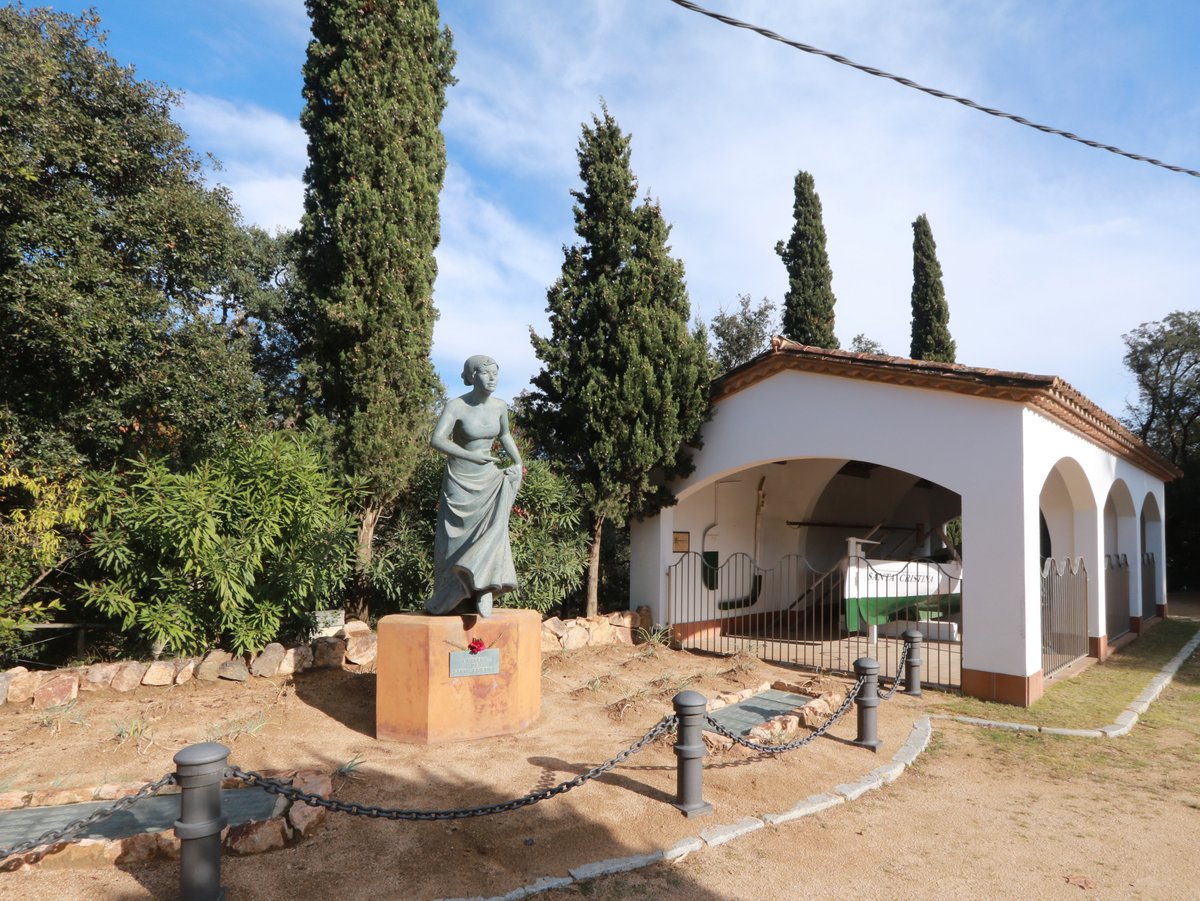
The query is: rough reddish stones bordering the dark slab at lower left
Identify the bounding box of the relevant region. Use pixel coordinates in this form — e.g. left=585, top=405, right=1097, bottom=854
left=0, top=770, right=334, bottom=872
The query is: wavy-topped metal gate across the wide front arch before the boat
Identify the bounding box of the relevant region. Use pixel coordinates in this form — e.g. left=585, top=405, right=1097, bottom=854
left=667, top=552, right=962, bottom=689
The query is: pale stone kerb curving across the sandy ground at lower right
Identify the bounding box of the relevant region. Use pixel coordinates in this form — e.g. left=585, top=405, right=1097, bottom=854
left=443, top=630, right=1200, bottom=901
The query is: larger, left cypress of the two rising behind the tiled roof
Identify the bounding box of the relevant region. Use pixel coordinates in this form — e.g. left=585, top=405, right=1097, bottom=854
left=775, top=172, right=840, bottom=349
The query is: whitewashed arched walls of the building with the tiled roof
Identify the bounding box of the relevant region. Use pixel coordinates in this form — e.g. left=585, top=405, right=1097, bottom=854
left=630, top=372, right=1165, bottom=675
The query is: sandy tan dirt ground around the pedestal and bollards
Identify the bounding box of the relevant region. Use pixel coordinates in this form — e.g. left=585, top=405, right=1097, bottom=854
left=0, top=595, right=1200, bottom=901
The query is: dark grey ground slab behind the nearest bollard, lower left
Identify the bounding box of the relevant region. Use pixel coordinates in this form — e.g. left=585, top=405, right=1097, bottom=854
left=0, top=788, right=275, bottom=847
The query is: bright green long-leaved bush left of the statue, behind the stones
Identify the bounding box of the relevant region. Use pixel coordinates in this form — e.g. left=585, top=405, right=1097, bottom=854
left=80, top=432, right=354, bottom=654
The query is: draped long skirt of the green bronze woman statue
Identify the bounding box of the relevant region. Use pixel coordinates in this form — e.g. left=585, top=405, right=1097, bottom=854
left=425, top=457, right=521, bottom=614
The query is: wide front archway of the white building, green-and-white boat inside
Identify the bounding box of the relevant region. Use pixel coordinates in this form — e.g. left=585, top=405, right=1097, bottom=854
left=668, top=457, right=970, bottom=686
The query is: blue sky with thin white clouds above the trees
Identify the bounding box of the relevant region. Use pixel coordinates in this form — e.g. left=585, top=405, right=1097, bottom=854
left=37, top=0, right=1200, bottom=415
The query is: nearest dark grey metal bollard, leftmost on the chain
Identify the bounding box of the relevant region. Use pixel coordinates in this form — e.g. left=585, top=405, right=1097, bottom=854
left=175, top=741, right=229, bottom=901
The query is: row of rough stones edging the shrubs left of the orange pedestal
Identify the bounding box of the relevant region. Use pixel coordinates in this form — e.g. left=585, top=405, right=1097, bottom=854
left=0, top=620, right=377, bottom=710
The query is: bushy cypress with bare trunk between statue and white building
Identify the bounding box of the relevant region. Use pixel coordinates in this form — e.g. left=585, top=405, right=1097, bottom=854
left=528, top=107, right=712, bottom=615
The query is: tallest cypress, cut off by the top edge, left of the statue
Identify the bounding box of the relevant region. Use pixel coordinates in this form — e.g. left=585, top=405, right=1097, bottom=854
left=298, top=0, right=455, bottom=615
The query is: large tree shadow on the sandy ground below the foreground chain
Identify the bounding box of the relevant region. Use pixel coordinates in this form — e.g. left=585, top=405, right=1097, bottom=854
left=98, top=758, right=720, bottom=901
